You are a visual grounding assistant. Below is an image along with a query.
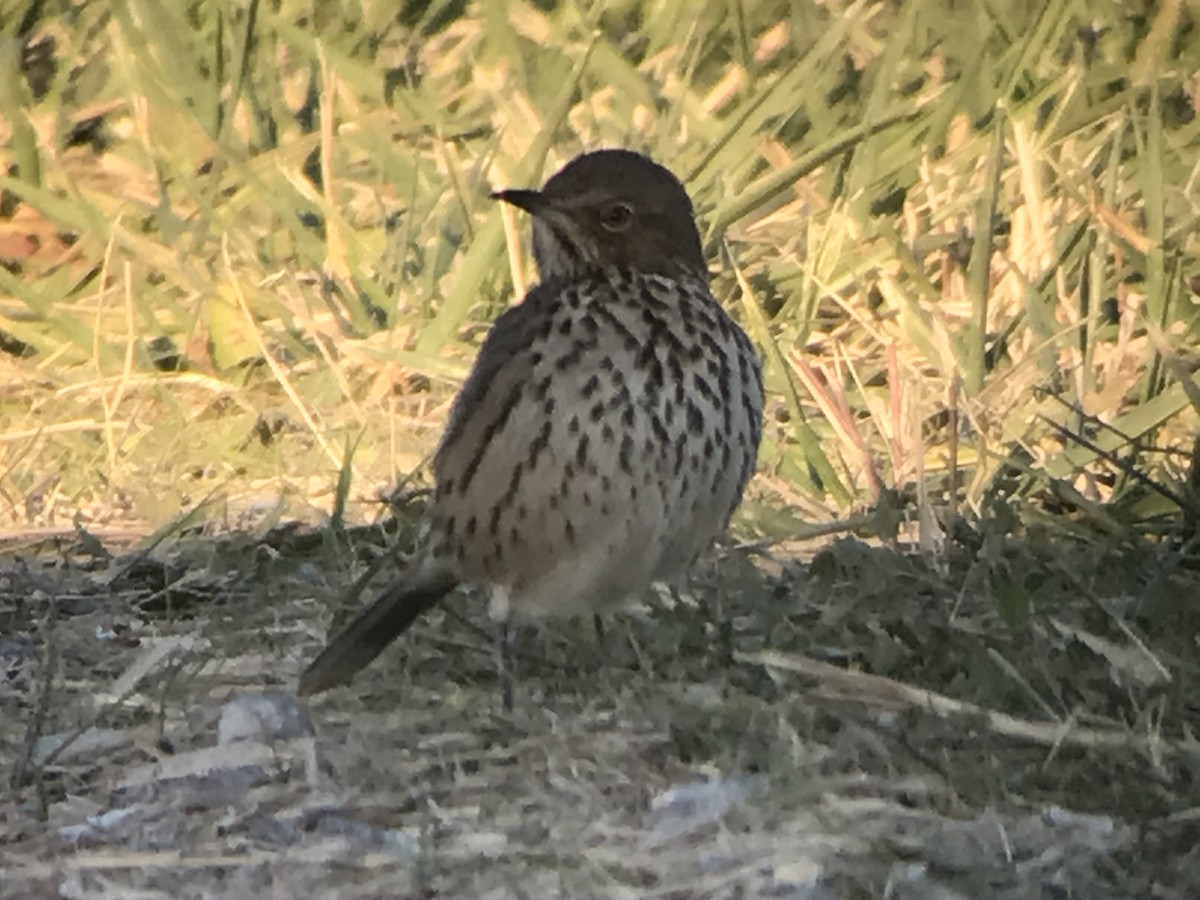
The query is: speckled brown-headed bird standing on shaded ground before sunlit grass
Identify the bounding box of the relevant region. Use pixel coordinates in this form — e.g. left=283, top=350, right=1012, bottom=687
left=299, top=149, right=763, bottom=695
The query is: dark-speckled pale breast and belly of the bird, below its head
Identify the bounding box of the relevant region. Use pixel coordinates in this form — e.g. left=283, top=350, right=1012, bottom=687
left=434, top=267, right=762, bottom=612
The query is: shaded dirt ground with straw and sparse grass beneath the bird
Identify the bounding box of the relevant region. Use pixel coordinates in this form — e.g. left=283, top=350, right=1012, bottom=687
left=0, top=520, right=1200, bottom=900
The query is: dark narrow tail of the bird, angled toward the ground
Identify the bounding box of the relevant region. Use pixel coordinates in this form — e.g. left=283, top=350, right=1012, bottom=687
left=299, top=574, right=457, bottom=697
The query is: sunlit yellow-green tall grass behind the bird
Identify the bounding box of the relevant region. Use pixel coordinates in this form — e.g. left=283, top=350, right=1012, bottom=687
left=0, top=0, right=1200, bottom=536
